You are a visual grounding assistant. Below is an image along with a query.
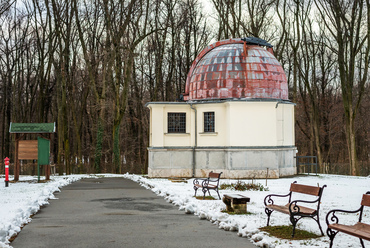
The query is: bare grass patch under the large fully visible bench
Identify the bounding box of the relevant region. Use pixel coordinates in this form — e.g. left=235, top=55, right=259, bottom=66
left=260, top=226, right=321, bottom=240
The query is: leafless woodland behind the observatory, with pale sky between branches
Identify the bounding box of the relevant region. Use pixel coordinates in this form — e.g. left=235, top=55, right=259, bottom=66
left=0, top=0, right=370, bottom=176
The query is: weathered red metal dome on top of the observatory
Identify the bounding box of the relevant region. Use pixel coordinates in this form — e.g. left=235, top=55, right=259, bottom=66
left=184, top=38, right=288, bottom=101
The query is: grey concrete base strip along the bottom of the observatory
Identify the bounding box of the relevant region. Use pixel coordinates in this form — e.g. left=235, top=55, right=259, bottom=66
left=148, top=147, right=296, bottom=179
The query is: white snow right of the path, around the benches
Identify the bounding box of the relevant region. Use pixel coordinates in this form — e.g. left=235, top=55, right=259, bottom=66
left=125, top=174, right=370, bottom=248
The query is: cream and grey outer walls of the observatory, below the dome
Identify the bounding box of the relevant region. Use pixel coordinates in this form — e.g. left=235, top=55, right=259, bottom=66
left=147, top=101, right=296, bottom=178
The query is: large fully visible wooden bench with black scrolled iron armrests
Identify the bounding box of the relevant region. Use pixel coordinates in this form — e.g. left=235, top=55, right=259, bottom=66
left=264, top=181, right=326, bottom=237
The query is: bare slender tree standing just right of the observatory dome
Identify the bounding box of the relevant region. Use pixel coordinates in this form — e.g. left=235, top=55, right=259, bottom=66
left=296, top=14, right=340, bottom=171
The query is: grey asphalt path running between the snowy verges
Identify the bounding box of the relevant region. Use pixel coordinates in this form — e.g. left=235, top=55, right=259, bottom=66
left=11, top=178, right=255, bottom=248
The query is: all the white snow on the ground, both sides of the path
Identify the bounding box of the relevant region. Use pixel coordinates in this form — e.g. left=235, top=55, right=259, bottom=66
left=0, top=174, right=370, bottom=248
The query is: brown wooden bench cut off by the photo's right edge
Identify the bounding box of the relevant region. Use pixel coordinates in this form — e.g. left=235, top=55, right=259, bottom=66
left=326, top=191, right=370, bottom=248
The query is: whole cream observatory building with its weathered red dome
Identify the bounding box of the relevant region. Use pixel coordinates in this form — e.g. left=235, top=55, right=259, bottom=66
left=146, top=38, right=297, bottom=179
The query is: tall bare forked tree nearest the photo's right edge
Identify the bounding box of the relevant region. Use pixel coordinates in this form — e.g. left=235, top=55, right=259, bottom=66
left=315, top=0, right=370, bottom=175
